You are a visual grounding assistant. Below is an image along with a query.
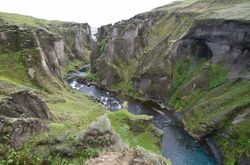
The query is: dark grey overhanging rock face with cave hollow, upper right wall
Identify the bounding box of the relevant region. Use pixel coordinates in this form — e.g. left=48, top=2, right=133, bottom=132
left=172, top=21, right=250, bottom=79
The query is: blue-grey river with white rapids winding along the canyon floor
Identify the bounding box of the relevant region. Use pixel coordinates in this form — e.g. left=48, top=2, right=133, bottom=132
left=68, top=70, right=216, bottom=165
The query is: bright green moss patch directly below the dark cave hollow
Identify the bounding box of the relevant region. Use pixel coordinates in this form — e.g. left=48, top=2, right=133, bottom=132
left=168, top=55, right=229, bottom=111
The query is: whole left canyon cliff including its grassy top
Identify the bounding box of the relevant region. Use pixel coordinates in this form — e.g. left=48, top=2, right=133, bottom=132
left=0, top=13, right=93, bottom=92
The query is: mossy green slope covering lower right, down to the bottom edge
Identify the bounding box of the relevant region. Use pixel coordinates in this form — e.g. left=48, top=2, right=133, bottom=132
left=175, top=77, right=250, bottom=164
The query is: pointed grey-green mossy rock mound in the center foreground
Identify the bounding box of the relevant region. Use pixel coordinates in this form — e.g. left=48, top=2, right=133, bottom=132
left=37, top=115, right=128, bottom=158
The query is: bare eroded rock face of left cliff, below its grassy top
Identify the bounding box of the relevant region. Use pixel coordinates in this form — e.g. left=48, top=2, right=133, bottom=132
left=0, top=21, right=93, bottom=92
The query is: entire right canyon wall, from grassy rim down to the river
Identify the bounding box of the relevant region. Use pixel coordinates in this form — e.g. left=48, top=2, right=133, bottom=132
left=90, top=0, right=250, bottom=164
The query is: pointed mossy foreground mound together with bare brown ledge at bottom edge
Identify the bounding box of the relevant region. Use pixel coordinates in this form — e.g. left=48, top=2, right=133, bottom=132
left=32, top=114, right=166, bottom=165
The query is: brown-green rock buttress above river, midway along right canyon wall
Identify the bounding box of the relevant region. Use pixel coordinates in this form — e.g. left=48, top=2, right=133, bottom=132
left=132, top=35, right=173, bottom=100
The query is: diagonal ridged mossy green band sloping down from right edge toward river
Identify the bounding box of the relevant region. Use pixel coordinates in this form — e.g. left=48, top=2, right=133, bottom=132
left=185, top=81, right=250, bottom=132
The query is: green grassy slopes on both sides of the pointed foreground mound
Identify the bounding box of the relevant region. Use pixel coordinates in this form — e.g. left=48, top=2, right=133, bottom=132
left=0, top=87, right=164, bottom=164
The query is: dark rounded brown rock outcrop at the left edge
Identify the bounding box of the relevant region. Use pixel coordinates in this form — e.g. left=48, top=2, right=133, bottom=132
left=0, top=91, right=54, bottom=148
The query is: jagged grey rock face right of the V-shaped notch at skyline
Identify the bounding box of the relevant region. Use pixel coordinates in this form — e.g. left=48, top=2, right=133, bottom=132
left=90, top=12, right=162, bottom=87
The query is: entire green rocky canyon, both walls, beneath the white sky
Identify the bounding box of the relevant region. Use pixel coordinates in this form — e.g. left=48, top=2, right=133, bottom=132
left=0, top=0, right=250, bottom=165
